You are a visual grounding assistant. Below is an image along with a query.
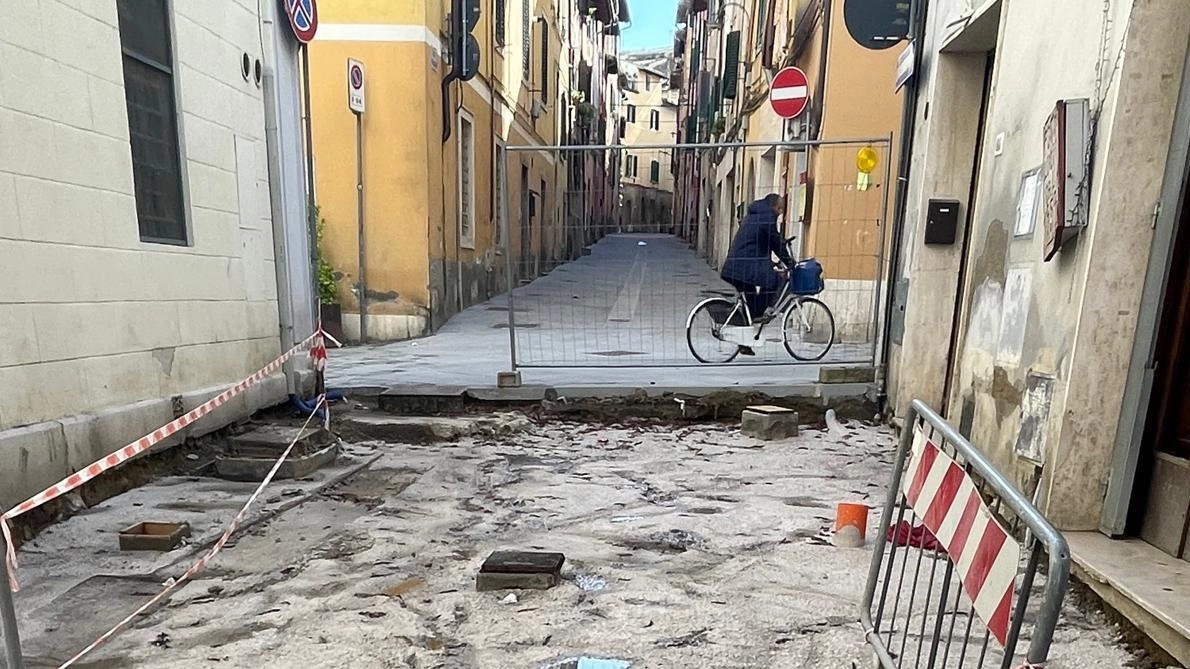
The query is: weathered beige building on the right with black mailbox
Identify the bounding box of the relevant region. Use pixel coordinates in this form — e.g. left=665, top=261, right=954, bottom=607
left=889, top=0, right=1190, bottom=663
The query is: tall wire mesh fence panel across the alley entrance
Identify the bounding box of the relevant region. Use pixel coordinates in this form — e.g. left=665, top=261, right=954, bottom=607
left=495, top=138, right=893, bottom=368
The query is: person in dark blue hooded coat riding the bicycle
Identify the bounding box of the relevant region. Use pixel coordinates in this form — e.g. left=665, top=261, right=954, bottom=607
left=720, top=193, right=794, bottom=355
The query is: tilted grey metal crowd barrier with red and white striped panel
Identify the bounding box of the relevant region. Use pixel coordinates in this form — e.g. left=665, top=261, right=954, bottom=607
left=860, top=400, right=1070, bottom=669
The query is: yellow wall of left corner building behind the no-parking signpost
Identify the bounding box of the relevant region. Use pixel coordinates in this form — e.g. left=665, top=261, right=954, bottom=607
left=311, top=0, right=566, bottom=339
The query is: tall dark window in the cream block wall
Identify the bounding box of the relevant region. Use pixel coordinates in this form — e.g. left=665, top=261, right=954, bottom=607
left=117, top=0, right=187, bottom=244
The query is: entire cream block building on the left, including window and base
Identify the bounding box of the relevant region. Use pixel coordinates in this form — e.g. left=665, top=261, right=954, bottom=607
left=0, top=0, right=314, bottom=508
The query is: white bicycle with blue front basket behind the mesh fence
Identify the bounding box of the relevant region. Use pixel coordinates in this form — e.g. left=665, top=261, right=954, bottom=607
left=685, top=238, right=834, bottom=364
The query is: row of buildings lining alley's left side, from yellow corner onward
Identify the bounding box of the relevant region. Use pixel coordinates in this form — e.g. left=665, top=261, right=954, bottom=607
left=311, top=0, right=619, bottom=340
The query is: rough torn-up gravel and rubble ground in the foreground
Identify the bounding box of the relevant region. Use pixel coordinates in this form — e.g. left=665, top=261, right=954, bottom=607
left=2, top=414, right=1170, bottom=669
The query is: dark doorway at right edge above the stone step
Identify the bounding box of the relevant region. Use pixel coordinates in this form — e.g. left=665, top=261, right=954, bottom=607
left=1136, top=165, right=1190, bottom=562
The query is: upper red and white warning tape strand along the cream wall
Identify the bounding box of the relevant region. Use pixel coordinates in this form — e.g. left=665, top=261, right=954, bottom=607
left=0, top=325, right=333, bottom=592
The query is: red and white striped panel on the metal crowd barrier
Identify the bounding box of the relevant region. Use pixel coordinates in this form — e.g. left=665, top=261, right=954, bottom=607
left=904, top=429, right=1021, bottom=644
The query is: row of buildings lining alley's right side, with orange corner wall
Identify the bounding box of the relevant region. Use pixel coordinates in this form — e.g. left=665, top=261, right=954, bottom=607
left=676, top=0, right=902, bottom=343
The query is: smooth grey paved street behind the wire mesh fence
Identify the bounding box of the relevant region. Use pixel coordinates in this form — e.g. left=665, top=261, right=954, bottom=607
left=327, top=235, right=870, bottom=389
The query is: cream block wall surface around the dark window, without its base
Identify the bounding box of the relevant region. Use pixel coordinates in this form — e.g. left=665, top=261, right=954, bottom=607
left=0, top=0, right=280, bottom=430
